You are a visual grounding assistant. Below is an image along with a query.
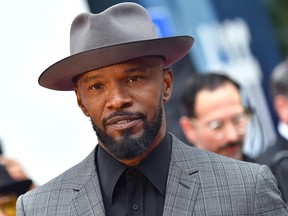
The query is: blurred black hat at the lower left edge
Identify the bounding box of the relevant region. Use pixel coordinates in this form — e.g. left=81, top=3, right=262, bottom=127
left=0, top=165, right=32, bottom=196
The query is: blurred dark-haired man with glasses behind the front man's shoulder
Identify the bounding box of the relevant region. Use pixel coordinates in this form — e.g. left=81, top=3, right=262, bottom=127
left=179, top=73, right=252, bottom=162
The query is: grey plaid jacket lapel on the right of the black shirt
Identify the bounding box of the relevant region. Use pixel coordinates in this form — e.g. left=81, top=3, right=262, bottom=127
left=163, top=135, right=200, bottom=216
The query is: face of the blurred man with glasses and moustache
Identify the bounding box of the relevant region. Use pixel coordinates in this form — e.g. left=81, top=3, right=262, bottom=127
left=182, top=83, right=248, bottom=160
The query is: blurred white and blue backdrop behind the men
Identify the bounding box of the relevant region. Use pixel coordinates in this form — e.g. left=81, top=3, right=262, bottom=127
left=0, top=0, right=288, bottom=185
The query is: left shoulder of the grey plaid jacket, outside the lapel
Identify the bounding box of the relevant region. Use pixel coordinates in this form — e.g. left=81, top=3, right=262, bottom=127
left=17, top=150, right=97, bottom=215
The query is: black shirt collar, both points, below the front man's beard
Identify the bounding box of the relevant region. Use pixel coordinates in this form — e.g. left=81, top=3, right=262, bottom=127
left=95, top=134, right=172, bottom=203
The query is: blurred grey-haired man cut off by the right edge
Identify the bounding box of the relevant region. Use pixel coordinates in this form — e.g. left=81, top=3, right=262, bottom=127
left=257, top=59, right=288, bottom=202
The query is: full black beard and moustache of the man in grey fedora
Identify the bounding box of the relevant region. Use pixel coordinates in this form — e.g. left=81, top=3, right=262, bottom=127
left=90, top=105, right=163, bottom=160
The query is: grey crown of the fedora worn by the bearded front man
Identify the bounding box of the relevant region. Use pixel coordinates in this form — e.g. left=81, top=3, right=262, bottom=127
left=70, top=3, right=158, bottom=55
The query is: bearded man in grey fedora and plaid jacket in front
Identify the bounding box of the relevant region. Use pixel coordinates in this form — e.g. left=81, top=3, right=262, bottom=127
left=17, top=3, right=288, bottom=216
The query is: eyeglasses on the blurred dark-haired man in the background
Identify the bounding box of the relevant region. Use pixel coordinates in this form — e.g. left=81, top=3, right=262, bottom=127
left=190, top=111, right=251, bottom=140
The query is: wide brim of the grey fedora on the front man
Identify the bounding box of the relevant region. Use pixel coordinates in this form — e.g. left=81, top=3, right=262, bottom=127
left=38, top=36, right=194, bottom=91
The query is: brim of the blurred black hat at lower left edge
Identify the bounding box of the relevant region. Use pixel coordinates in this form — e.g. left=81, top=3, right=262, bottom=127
left=0, top=179, right=32, bottom=196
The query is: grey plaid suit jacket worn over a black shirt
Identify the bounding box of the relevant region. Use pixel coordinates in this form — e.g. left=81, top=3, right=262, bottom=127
left=17, top=135, right=288, bottom=216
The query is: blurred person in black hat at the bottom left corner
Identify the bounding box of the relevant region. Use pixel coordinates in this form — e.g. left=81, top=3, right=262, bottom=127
left=0, top=165, right=32, bottom=216
